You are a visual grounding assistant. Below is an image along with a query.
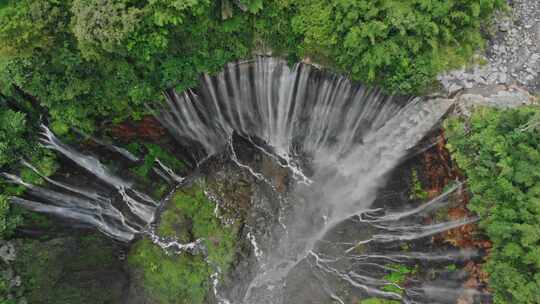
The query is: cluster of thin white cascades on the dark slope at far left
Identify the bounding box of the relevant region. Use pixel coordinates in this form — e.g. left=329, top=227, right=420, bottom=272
left=3, top=125, right=157, bottom=242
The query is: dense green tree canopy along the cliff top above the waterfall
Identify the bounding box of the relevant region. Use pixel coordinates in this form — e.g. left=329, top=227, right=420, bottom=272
left=0, top=0, right=503, bottom=133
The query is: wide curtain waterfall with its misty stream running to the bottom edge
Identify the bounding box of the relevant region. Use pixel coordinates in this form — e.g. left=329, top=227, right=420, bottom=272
left=152, top=57, right=460, bottom=303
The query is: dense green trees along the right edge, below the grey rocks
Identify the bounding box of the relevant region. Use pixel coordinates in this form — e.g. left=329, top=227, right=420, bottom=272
left=446, top=107, right=540, bottom=304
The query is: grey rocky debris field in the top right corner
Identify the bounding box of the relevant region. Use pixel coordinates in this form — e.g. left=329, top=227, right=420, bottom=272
left=438, top=0, right=540, bottom=96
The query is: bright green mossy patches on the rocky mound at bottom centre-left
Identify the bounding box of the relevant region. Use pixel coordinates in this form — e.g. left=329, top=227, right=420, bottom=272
left=128, top=185, right=237, bottom=304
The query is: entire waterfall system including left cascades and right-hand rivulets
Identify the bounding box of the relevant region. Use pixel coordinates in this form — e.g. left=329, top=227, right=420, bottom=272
left=6, top=57, right=480, bottom=304
